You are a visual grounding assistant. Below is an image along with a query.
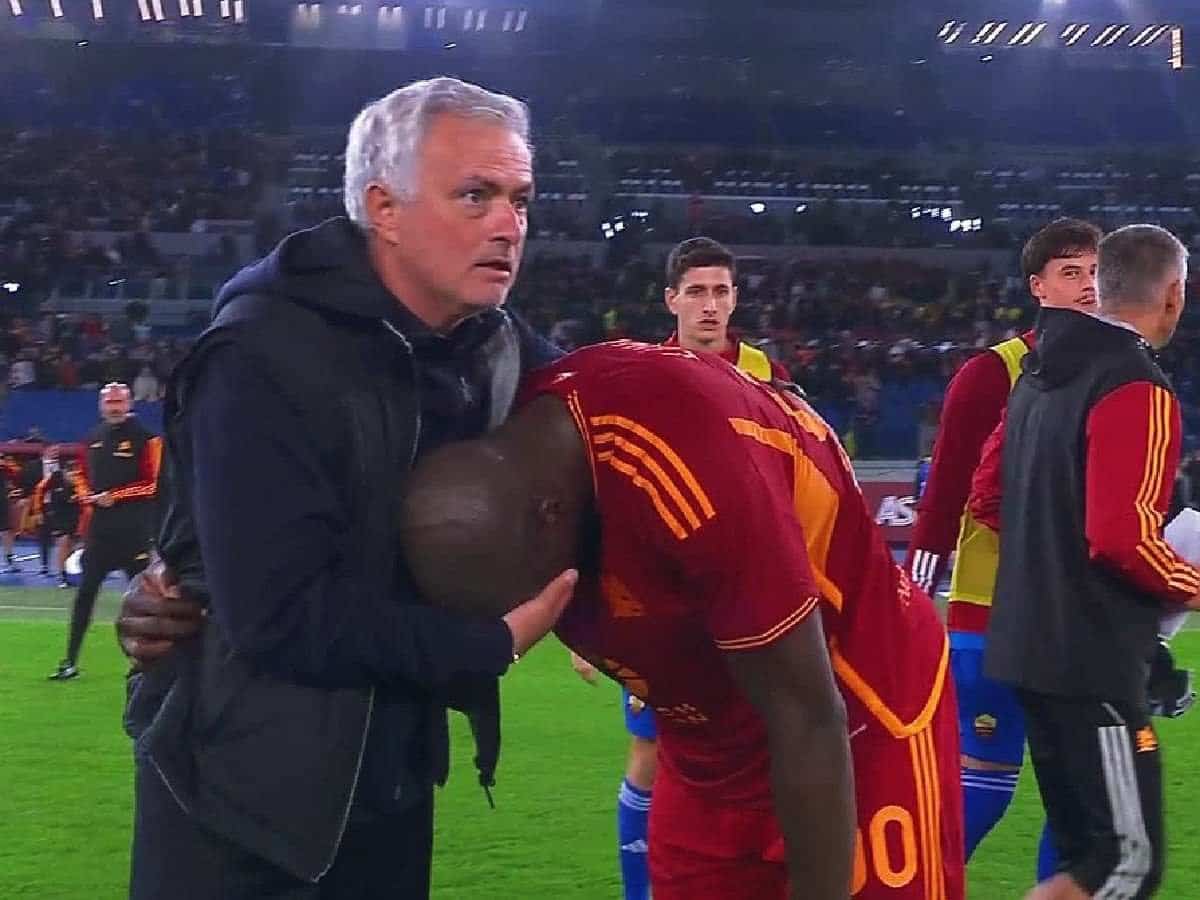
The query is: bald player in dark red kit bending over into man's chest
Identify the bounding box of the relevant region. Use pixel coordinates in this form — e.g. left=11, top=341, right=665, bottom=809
left=401, top=341, right=964, bottom=900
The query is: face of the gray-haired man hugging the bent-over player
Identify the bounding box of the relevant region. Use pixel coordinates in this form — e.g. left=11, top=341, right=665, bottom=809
left=383, top=115, right=533, bottom=324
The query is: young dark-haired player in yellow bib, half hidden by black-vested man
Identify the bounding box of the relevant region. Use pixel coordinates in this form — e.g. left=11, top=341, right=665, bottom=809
left=907, top=218, right=1100, bottom=871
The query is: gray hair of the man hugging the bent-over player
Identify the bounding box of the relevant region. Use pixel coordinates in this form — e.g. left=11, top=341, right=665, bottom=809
left=342, top=77, right=529, bottom=228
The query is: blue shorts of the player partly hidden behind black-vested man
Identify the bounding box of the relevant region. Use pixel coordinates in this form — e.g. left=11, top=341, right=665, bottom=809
left=950, top=631, right=1025, bottom=766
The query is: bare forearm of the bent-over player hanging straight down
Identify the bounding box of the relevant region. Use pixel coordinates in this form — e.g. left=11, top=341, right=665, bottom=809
left=725, top=610, right=856, bottom=900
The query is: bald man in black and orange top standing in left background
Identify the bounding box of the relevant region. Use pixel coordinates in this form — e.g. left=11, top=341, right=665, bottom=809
left=50, top=382, right=162, bottom=682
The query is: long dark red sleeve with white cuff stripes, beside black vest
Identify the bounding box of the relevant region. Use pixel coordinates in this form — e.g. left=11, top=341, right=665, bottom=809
left=905, top=352, right=1010, bottom=594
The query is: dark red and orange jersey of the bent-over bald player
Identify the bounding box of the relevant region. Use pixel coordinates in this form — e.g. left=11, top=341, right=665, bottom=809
left=524, top=341, right=947, bottom=804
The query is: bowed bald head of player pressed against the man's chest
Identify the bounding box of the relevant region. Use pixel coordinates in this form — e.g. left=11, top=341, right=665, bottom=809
left=401, top=397, right=592, bottom=616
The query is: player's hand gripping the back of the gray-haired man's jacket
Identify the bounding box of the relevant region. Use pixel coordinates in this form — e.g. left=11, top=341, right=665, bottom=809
left=116, top=559, right=205, bottom=666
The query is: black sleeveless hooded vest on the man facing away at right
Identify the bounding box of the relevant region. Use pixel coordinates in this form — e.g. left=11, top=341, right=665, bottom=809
left=985, top=310, right=1170, bottom=708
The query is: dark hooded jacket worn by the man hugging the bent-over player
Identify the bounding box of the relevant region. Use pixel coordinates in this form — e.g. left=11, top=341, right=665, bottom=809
left=126, top=218, right=557, bottom=881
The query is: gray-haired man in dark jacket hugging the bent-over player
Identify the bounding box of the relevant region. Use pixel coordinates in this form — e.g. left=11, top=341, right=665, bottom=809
left=118, top=78, right=576, bottom=900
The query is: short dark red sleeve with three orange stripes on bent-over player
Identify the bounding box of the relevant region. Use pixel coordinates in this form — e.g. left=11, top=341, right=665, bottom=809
left=568, top=364, right=817, bottom=652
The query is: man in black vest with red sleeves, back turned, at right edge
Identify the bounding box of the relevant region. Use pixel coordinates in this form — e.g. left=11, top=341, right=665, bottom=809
left=985, top=226, right=1200, bottom=900
